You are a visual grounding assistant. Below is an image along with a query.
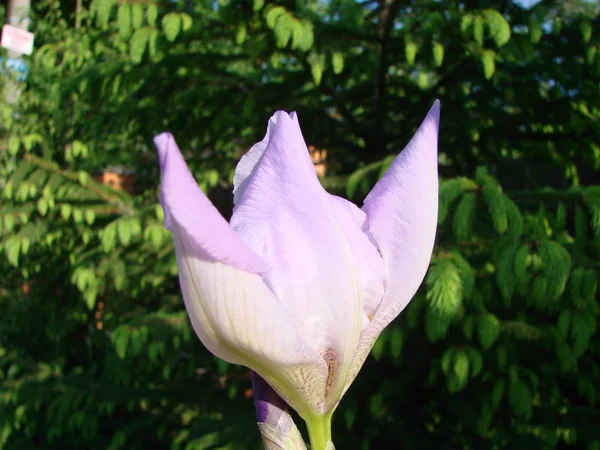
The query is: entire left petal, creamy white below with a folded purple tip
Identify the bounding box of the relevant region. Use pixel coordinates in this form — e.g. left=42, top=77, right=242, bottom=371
left=155, top=134, right=327, bottom=412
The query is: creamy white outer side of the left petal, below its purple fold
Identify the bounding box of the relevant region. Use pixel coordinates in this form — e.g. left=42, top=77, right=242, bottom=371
left=172, top=223, right=327, bottom=414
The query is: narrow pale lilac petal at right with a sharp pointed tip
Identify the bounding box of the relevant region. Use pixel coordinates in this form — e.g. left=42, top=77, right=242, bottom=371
left=349, top=101, right=440, bottom=388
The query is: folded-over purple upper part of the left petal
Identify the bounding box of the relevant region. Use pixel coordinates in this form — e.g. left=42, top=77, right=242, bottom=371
left=154, top=133, right=268, bottom=272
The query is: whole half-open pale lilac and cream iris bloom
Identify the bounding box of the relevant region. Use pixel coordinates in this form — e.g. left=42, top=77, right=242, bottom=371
left=155, top=102, right=439, bottom=448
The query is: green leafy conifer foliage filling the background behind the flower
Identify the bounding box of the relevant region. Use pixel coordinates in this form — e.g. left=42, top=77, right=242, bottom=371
left=0, top=0, right=600, bottom=450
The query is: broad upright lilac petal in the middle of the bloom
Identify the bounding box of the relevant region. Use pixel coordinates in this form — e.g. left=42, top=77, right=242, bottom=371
left=231, top=112, right=363, bottom=408
